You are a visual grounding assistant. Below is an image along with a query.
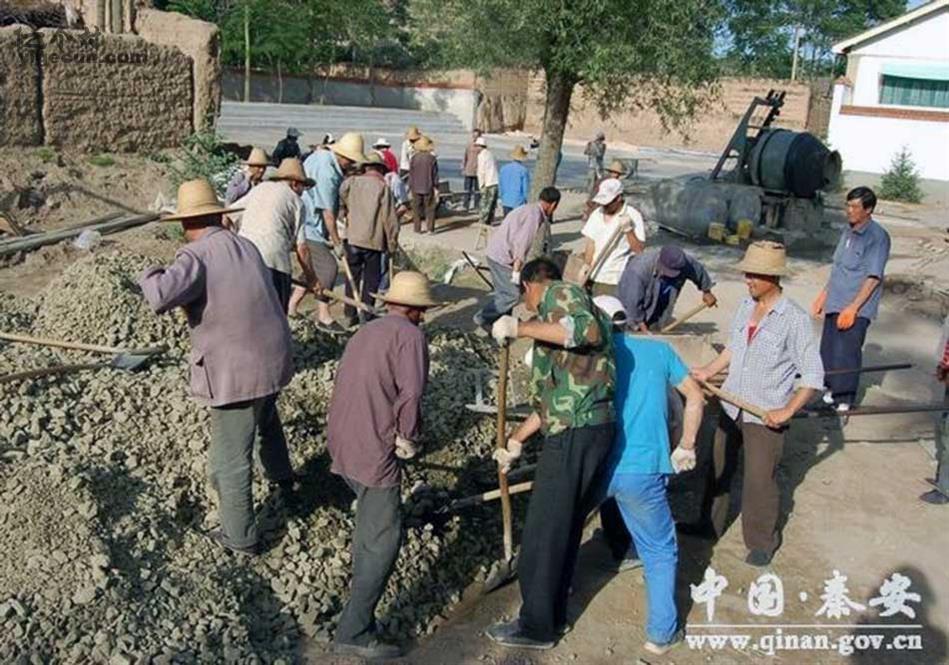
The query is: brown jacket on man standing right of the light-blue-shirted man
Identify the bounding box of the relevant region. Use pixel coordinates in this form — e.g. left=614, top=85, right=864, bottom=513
left=339, top=173, right=399, bottom=252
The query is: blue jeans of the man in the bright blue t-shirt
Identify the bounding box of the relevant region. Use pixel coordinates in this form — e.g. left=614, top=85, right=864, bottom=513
left=606, top=473, right=679, bottom=644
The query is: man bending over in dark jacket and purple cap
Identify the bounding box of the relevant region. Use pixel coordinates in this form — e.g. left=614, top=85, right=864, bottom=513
left=617, top=245, right=718, bottom=332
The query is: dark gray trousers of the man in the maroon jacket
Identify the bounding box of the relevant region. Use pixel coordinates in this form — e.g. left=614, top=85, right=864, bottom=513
left=335, top=477, right=402, bottom=646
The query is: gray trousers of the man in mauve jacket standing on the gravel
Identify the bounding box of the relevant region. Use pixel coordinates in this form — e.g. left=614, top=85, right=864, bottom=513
left=208, top=394, right=293, bottom=547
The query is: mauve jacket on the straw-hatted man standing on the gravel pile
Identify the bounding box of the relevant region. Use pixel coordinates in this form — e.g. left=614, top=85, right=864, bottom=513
left=139, top=228, right=293, bottom=406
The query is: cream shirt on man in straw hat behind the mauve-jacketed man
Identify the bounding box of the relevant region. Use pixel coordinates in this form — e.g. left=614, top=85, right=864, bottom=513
left=235, top=181, right=303, bottom=275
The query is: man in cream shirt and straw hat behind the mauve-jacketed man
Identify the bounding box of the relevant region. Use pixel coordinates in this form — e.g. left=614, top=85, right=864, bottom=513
left=238, top=158, right=318, bottom=312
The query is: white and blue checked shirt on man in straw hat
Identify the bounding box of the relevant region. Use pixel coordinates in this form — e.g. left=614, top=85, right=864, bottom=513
left=722, top=296, right=824, bottom=425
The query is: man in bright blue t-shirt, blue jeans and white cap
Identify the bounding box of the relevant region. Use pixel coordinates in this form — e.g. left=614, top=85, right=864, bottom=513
left=594, top=296, right=705, bottom=655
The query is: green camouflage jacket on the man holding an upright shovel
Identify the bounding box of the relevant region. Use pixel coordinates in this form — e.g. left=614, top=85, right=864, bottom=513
left=531, top=282, right=616, bottom=436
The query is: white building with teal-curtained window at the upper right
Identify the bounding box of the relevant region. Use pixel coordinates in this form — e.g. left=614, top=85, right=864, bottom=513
left=827, top=0, right=949, bottom=180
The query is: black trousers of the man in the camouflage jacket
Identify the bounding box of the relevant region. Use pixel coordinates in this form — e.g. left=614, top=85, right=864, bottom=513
left=517, top=423, right=614, bottom=640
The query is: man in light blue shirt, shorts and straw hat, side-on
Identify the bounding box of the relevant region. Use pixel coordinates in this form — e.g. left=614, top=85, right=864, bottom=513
left=289, top=132, right=366, bottom=333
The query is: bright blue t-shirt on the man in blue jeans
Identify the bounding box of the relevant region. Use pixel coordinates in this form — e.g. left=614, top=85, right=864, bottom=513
left=611, top=333, right=689, bottom=474
